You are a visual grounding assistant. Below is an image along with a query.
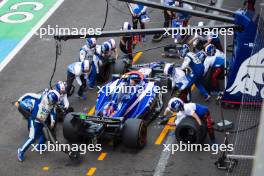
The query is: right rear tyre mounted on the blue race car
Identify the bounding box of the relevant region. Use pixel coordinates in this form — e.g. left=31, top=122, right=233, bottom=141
left=122, top=119, right=147, bottom=149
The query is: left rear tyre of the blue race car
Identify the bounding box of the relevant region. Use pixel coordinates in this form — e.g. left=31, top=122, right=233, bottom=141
left=63, top=113, right=81, bottom=142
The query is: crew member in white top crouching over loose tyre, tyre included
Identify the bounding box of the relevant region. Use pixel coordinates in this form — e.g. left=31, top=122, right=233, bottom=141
left=162, top=97, right=216, bottom=145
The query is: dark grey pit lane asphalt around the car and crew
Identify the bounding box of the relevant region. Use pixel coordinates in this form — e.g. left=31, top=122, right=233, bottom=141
left=0, top=0, right=260, bottom=176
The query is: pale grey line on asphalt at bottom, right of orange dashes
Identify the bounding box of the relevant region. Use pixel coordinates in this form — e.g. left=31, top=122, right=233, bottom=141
left=153, top=131, right=174, bottom=176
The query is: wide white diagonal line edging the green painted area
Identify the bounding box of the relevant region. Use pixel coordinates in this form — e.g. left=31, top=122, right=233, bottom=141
left=0, top=0, right=64, bottom=72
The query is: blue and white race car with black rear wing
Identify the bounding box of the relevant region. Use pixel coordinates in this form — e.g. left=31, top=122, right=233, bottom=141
left=63, top=71, right=163, bottom=149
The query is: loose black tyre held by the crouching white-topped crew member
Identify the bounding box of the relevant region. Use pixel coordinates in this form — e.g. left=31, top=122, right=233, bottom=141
left=175, top=116, right=206, bottom=144
